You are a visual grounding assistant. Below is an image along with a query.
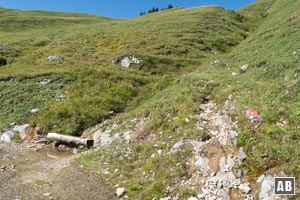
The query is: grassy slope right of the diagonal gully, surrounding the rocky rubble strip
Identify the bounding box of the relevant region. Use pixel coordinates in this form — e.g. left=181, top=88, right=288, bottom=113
left=79, top=1, right=300, bottom=199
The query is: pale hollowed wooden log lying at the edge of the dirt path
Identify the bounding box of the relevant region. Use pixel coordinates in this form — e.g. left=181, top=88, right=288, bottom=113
left=47, top=133, right=94, bottom=147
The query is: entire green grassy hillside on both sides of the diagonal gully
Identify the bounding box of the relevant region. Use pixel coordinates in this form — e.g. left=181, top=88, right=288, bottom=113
left=0, top=0, right=300, bottom=199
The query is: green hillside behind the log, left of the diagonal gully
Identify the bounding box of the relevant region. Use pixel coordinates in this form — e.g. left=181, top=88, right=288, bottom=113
left=0, top=6, right=247, bottom=135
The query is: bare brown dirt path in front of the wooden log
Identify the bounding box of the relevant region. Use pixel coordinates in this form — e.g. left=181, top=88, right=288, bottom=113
left=0, top=143, right=116, bottom=200
